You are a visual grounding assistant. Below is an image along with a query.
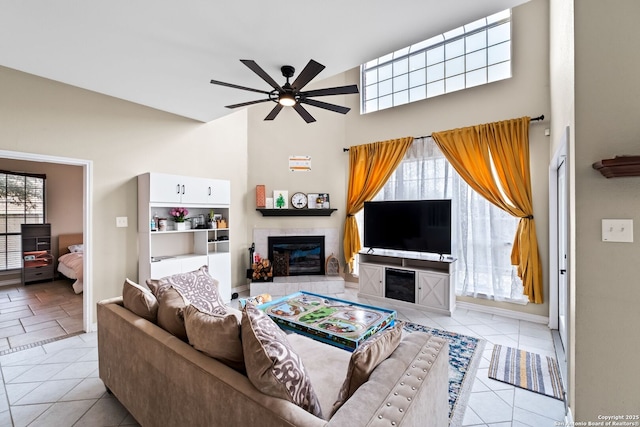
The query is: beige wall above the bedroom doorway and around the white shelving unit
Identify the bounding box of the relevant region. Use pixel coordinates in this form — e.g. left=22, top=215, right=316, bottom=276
left=0, top=67, right=248, bottom=321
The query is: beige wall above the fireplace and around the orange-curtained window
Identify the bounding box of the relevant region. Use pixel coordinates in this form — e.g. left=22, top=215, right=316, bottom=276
left=246, top=0, right=550, bottom=316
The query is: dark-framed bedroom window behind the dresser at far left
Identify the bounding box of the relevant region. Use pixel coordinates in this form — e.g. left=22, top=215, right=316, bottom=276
left=0, top=171, right=46, bottom=271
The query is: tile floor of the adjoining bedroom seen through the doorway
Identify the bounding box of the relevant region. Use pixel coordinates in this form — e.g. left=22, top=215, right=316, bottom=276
left=0, top=280, right=82, bottom=354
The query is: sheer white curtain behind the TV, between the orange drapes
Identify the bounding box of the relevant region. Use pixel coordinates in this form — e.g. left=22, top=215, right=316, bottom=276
left=356, top=138, right=527, bottom=303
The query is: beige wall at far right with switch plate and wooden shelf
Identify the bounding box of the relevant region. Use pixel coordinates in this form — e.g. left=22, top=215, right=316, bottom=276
left=573, top=0, right=640, bottom=421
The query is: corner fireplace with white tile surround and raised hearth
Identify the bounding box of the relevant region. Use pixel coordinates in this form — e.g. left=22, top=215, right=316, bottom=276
left=250, top=228, right=344, bottom=297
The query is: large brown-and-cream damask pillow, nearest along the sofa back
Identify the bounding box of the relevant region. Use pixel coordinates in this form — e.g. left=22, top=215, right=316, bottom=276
left=240, top=304, right=322, bottom=418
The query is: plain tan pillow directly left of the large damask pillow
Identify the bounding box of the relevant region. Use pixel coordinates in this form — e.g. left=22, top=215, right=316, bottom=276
left=184, top=305, right=245, bottom=373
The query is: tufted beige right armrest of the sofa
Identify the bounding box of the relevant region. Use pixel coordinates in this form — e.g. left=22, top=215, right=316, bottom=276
left=328, top=332, right=449, bottom=427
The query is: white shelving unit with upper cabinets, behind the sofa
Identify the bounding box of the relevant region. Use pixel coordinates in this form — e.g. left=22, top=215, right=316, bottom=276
left=138, top=173, right=231, bottom=302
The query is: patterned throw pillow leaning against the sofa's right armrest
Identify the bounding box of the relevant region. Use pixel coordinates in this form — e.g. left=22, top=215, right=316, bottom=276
left=332, top=320, right=403, bottom=416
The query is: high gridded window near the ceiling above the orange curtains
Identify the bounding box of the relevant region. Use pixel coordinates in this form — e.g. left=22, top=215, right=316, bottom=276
left=360, top=10, right=511, bottom=113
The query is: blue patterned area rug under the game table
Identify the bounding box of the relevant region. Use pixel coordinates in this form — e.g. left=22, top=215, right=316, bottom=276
left=404, top=322, right=485, bottom=427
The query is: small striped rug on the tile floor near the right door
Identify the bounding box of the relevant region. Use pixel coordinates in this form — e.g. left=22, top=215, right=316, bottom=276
left=489, top=345, right=564, bottom=400
